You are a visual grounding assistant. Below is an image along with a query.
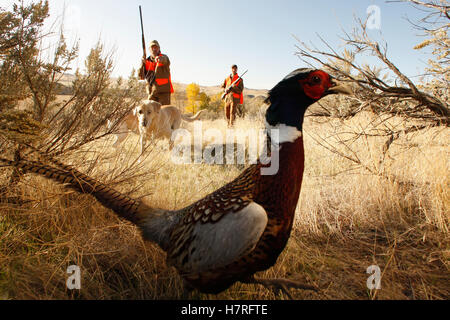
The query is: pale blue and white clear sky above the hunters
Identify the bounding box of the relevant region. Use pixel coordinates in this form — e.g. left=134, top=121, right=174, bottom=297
left=0, top=0, right=429, bottom=89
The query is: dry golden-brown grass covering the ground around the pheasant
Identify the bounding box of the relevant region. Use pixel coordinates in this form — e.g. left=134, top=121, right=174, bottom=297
left=0, top=114, right=450, bottom=299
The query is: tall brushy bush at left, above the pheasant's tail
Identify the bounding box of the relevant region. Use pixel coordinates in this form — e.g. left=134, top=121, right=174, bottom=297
left=0, top=1, right=149, bottom=198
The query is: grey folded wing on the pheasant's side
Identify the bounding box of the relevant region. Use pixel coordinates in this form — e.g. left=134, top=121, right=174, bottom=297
left=168, top=198, right=268, bottom=274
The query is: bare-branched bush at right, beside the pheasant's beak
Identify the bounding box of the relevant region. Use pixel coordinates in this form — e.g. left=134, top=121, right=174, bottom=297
left=298, top=1, right=450, bottom=176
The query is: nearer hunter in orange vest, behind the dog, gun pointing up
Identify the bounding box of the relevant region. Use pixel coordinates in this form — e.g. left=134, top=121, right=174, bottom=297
left=139, top=40, right=173, bottom=105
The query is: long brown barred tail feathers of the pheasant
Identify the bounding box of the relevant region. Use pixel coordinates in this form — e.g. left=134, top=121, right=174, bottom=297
left=0, top=158, right=156, bottom=226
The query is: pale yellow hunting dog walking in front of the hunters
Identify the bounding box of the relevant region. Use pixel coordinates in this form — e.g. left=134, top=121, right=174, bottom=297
left=113, top=100, right=203, bottom=155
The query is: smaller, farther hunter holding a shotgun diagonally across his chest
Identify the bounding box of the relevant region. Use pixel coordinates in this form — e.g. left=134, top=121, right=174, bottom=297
left=222, top=64, right=244, bottom=127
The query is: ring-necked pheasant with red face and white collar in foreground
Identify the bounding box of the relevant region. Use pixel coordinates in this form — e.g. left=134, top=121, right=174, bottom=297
left=2, top=69, right=351, bottom=293
